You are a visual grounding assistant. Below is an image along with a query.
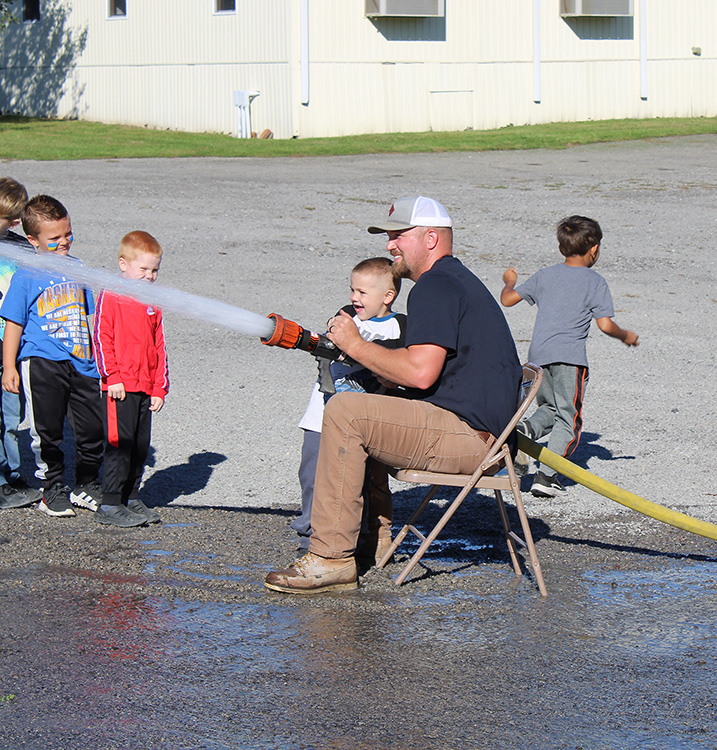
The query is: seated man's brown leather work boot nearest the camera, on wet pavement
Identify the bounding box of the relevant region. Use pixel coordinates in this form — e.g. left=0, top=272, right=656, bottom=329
left=264, top=552, right=358, bottom=594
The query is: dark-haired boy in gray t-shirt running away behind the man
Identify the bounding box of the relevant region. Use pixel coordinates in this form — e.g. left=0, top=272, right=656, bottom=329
left=500, top=216, right=638, bottom=497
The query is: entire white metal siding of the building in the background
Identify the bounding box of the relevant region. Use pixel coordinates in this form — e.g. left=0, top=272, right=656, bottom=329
left=0, top=0, right=717, bottom=138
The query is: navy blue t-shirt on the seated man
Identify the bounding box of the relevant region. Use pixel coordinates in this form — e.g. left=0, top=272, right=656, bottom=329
left=406, top=256, right=523, bottom=437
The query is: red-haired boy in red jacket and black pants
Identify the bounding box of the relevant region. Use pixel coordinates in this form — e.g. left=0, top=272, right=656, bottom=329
left=94, top=231, right=169, bottom=528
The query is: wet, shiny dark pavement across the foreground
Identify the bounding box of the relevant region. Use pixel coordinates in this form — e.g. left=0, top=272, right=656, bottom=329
left=0, top=540, right=717, bottom=750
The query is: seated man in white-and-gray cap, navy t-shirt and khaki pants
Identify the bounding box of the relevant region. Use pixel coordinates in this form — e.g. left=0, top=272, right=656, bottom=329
left=264, top=196, right=522, bottom=594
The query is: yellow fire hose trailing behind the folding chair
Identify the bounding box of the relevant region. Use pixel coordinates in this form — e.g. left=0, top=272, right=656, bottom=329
left=518, top=433, right=717, bottom=539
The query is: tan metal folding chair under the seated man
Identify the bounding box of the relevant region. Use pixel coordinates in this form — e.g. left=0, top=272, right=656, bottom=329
left=378, top=363, right=548, bottom=596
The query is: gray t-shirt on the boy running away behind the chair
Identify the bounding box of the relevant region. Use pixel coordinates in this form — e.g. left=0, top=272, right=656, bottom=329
left=515, top=263, right=615, bottom=367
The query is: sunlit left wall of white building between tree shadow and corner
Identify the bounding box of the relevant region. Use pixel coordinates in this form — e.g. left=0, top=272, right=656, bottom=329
left=63, top=0, right=292, bottom=133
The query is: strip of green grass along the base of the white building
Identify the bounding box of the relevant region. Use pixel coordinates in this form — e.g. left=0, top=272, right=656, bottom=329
left=0, top=116, right=717, bottom=161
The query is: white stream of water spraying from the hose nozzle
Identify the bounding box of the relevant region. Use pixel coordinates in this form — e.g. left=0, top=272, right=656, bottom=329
left=0, top=240, right=274, bottom=338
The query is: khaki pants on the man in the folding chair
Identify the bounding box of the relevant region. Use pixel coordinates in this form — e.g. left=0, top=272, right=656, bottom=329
left=309, top=392, right=493, bottom=558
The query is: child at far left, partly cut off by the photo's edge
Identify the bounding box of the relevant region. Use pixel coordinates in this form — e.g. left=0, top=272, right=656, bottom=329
left=0, top=177, right=42, bottom=509
